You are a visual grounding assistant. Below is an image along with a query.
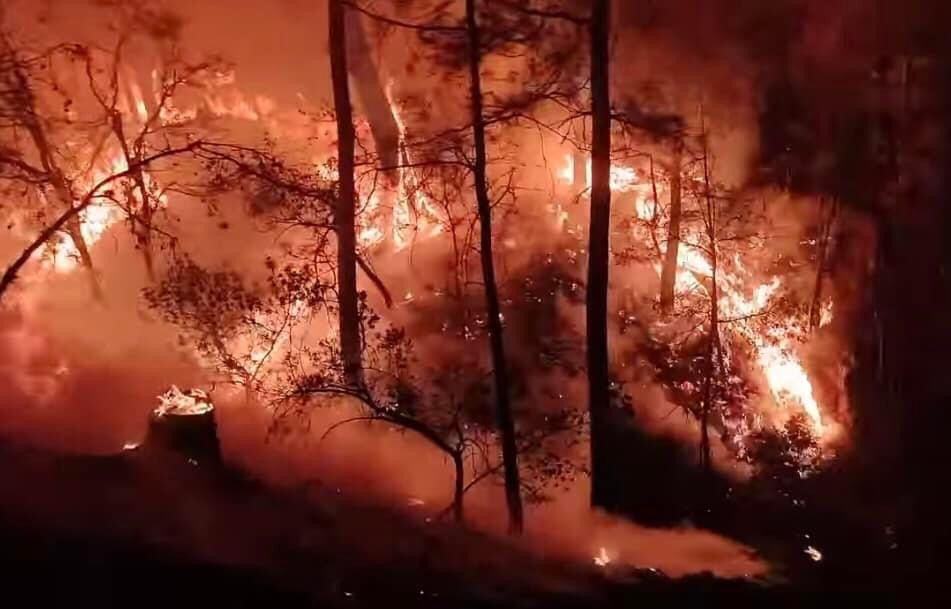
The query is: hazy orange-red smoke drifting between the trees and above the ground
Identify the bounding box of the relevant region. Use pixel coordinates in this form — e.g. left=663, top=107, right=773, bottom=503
left=0, top=0, right=896, bottom=576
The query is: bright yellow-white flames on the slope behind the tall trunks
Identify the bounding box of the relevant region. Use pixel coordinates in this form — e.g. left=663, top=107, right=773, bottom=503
left=31, top=59, right=834, bottom=464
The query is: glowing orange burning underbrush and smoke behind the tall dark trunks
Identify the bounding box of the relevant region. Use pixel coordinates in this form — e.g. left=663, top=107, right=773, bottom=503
left=0, top=0, right=867, bottom=588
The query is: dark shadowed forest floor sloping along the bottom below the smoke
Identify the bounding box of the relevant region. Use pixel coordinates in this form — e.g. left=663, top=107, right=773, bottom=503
left=0, top=436, right=900, bottom=608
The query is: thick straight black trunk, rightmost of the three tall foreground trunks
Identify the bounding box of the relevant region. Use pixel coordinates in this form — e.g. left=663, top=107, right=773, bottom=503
left=586, top=0, right=614, bottom=508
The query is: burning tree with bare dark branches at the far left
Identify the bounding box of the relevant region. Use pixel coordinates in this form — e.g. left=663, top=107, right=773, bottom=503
left=0, top=8, right=236, bottom=298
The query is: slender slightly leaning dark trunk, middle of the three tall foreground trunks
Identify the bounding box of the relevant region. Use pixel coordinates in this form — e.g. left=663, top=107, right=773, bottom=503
left=466, top=0, right=523, bottom=532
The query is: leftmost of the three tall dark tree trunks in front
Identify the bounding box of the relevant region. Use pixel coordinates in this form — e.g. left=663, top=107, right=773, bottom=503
left=329, top=0, right=363, bottom=385
